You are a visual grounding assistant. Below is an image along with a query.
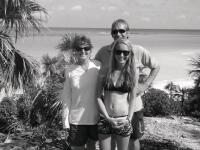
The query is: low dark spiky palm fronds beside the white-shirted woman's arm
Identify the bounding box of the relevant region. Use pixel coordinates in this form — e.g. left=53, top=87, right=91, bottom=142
left=30, top=80, right=62, bottom=127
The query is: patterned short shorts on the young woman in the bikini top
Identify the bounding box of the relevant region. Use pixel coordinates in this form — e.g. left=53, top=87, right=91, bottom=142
left=98, top=117, right=132, bottom=137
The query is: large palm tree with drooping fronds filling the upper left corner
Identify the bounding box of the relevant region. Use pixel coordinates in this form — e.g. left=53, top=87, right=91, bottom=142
left=0, top=0, right=47, bottom=89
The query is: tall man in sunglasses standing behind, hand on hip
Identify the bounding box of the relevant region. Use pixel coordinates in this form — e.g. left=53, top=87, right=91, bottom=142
left=95, top=19, right=160, bottom=150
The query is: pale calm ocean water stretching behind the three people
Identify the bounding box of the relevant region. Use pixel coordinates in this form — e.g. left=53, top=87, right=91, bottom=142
left=16, top=28, right=200, bottom=88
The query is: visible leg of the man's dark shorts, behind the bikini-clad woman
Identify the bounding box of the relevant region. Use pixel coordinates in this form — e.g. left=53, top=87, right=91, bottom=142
left=130, top=110, right=144, bottom=140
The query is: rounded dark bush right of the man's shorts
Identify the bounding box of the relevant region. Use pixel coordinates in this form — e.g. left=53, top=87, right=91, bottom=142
left=142, top=88, right=173, bottom=117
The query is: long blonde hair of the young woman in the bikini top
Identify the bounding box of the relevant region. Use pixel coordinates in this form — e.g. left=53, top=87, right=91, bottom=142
left=106, top=38, right=136, bottom=89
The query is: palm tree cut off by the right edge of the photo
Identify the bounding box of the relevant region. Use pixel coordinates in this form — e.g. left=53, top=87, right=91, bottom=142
left=189, top=55, right=200, bottom=88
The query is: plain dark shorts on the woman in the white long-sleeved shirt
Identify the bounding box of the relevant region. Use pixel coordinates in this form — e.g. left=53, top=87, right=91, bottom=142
left=68, top=124, right=98, bottom=146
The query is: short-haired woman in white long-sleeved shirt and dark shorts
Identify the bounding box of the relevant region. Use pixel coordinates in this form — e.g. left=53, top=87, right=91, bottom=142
left=62, top=36, right=100, bottom=150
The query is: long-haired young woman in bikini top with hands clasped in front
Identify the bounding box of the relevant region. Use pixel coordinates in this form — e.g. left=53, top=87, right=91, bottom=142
left=97, top=38, right=138, bottom=150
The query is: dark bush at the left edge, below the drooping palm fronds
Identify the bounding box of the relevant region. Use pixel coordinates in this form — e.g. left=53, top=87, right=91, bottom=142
left=0, top=97, right=17, bottom=133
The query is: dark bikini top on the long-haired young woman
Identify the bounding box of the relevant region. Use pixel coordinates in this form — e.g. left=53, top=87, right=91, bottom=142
left=104, top=82, right=131, bottom=93
